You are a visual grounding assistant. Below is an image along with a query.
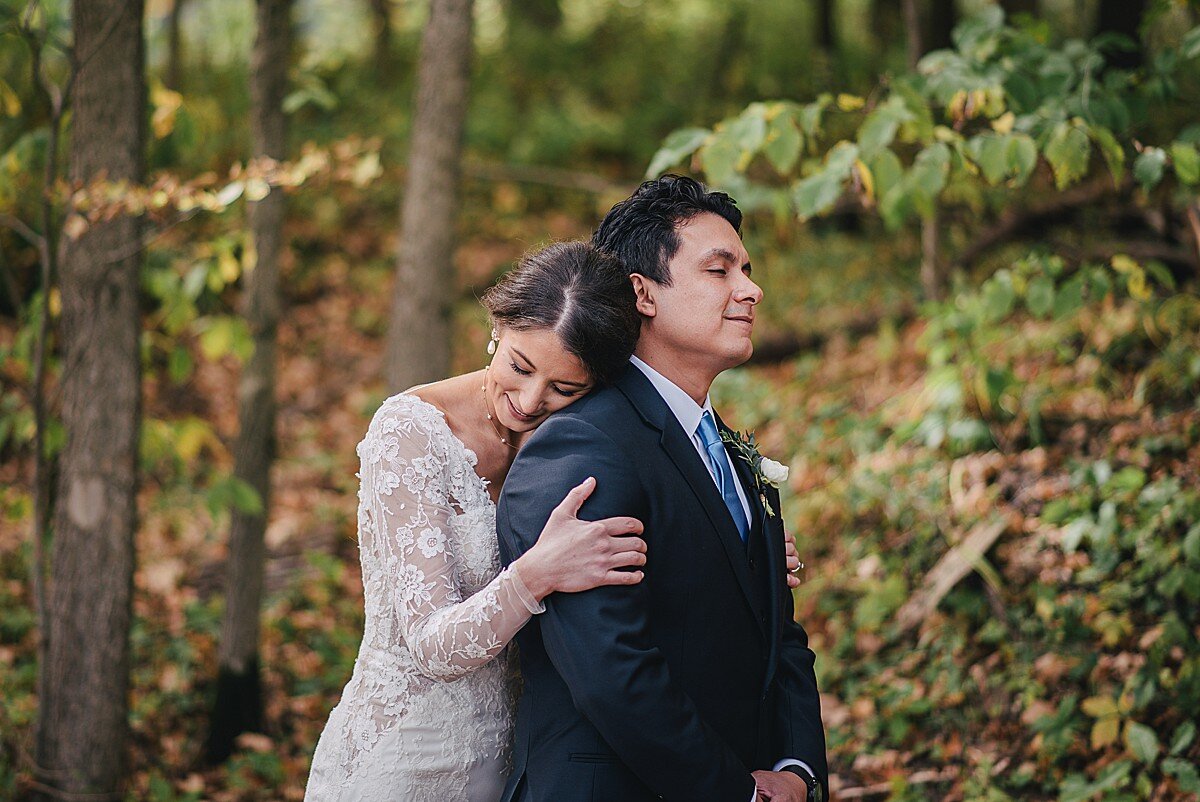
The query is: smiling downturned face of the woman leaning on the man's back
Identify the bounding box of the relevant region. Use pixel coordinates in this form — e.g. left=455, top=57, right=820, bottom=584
left=485, top=327, right=592, bottom=432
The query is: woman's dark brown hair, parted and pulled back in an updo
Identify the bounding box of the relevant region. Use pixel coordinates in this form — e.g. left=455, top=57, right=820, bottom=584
left=481, top=243, right=640, bottom=384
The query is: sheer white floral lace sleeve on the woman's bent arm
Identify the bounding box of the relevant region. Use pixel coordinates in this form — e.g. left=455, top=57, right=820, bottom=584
left=360, top=398, right=545, bottom=680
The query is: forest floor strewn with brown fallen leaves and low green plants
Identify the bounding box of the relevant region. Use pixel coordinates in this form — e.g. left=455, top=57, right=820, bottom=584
left=0, top=185, right=1200, bottom=801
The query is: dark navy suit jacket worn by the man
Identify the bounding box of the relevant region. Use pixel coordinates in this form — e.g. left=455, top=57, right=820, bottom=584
left=497, top=365, right=828, bottom=802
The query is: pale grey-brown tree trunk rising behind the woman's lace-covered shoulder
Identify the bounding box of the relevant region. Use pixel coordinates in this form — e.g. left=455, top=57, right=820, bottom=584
left=386, top=0, right=472, bottom=390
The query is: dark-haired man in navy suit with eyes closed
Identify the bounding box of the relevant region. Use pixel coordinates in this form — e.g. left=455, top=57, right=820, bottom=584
left=497, top=175, right=828, bottom=802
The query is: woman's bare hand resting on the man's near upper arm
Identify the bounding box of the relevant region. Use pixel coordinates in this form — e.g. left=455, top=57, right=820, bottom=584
left=514, top=477, right=646, bottom=602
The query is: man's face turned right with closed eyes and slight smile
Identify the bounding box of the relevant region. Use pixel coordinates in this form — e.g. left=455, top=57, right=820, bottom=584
left=635, top=213, right=762, bottom=375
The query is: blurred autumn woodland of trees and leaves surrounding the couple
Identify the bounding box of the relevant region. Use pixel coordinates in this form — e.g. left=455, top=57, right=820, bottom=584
left=0, top=0, right=1200, bottom=802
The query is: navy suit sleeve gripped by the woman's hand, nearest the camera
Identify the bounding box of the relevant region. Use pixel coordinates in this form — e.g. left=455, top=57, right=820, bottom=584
left=498, top=415, right=755, bottom=800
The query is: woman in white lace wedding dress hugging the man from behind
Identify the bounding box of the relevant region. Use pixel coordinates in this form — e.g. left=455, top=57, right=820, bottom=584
left=305, top=243, right=797, bottom=802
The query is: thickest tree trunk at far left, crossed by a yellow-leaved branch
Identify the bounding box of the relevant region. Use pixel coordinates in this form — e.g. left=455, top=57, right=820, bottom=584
left=36, top=0, right=146, bottom=798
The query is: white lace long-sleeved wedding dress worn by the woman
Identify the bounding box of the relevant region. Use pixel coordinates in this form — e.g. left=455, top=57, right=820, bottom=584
left=305, top=393, right=544, bottom=802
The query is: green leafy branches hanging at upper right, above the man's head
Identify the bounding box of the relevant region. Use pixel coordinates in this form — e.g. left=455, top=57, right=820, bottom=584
left=647, top=6, right=1200, bottom=229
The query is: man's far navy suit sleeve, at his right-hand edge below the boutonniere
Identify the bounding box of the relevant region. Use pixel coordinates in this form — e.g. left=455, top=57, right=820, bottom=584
left=770, top=482, right=829, bottom=789
